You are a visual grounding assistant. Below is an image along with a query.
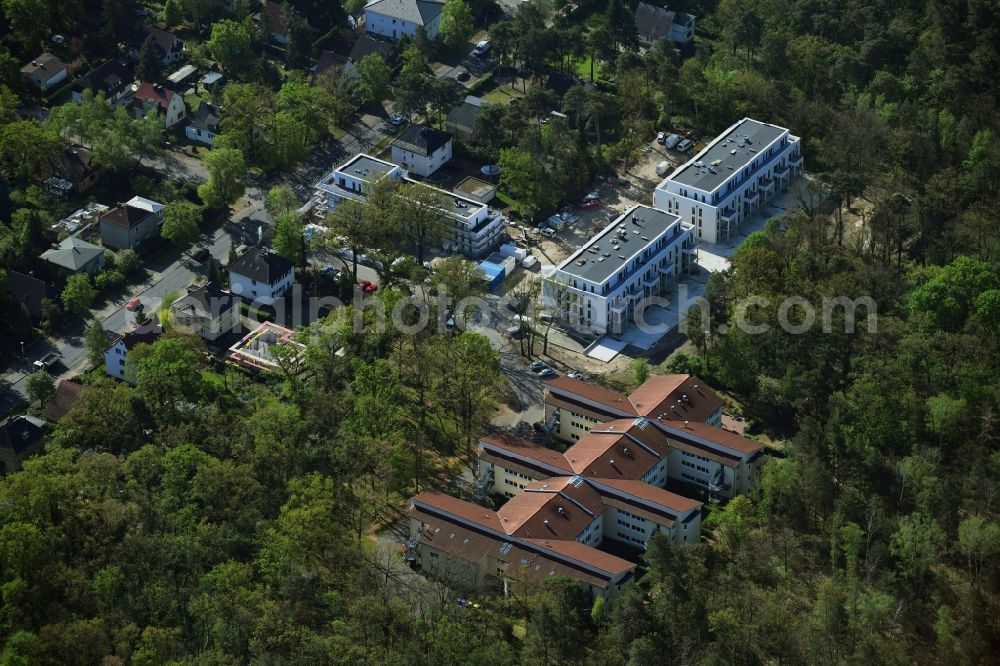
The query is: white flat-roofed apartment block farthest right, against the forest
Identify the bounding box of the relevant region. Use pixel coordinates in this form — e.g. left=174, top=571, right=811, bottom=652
left=653, top=118, right=802, bottom=243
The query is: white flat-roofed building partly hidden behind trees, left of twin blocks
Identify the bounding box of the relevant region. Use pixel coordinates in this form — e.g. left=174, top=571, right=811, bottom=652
left=306, top=153, right=503, bottom=258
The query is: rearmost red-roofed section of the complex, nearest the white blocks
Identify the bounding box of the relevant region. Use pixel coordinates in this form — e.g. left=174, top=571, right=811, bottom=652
left=544, top=375, right=765, bottom=498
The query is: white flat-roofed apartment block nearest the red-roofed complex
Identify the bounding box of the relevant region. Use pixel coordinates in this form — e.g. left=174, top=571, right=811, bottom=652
left=543, top=205, right=695, bottom=335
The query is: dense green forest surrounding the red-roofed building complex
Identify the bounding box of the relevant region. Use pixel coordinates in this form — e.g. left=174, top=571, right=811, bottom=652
left=0, top=0, right=1000, bottom=666
